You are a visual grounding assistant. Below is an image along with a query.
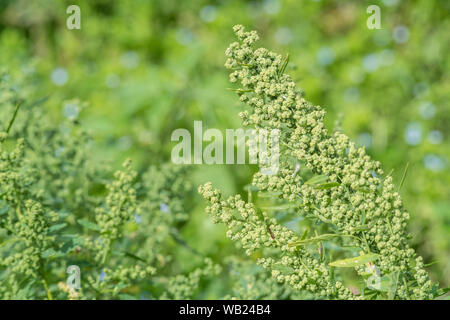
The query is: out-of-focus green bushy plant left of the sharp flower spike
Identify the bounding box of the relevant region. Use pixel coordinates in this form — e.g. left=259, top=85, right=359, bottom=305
left=0, top=76, right=220, bottom=299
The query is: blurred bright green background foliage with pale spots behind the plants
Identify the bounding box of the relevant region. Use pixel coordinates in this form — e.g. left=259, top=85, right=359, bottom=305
left=0, top=0, right=450, bottom=286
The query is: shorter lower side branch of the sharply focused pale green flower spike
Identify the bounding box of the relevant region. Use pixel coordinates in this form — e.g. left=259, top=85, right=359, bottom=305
left=199, top=183, right=352, bottom=299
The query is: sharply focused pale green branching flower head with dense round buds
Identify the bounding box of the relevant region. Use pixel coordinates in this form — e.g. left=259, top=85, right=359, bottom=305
left=199, top=25, right=436, bottom=299
